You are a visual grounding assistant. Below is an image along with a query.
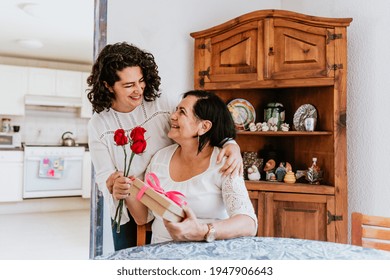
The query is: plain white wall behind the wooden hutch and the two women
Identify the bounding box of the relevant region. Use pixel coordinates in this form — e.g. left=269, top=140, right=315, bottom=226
left=107, top=0, right=390, bottom=241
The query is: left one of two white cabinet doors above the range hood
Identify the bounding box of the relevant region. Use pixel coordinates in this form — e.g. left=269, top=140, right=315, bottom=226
left=28, top=67, right=56, bottom=96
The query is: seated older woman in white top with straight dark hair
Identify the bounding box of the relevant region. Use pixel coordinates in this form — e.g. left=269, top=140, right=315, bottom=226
left=120, top=91, right=257, bottom=243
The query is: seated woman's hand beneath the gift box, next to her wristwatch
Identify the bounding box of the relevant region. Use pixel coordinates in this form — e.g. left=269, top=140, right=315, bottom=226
left=164, top=207, right=208, bottom=241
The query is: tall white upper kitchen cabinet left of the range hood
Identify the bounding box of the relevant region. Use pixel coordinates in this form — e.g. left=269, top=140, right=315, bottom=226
left=0, top=65, right=27, bottom=116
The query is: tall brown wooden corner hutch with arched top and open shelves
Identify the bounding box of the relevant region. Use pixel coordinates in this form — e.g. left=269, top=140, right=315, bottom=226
left=191, top=10, right=352, bottom=243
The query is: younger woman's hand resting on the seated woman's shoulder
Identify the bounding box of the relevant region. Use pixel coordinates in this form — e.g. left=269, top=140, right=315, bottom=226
left=217, top=143, right=244, bottom=178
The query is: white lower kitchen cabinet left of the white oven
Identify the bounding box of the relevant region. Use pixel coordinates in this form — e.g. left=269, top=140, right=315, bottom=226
left=0, top=150, right=23, bottom=202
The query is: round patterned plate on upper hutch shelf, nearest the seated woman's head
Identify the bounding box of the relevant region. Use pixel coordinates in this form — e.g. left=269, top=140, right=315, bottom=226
left=227, top=98, right=256, bottom=130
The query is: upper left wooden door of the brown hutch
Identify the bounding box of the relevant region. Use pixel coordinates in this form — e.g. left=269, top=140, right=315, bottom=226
left=195, top=21, right=263, bottom=87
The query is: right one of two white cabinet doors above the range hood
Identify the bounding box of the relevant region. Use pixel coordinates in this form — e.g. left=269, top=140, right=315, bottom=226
left=56, top=70, right=82, bottom=98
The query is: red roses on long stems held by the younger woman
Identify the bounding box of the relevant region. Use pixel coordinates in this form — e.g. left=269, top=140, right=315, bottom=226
left=113, top=126, right=146, bottom=233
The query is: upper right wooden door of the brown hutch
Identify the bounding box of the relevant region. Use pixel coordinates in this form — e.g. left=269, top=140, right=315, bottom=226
left=264, top=18, right=337, bottom=79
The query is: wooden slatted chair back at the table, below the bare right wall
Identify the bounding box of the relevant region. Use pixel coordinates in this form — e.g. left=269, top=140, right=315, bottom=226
left=351, top=212, right=390, bottom=251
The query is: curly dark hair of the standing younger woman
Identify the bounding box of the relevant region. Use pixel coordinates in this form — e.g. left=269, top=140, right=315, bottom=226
left=87, top=42, right=161, bottom=113
